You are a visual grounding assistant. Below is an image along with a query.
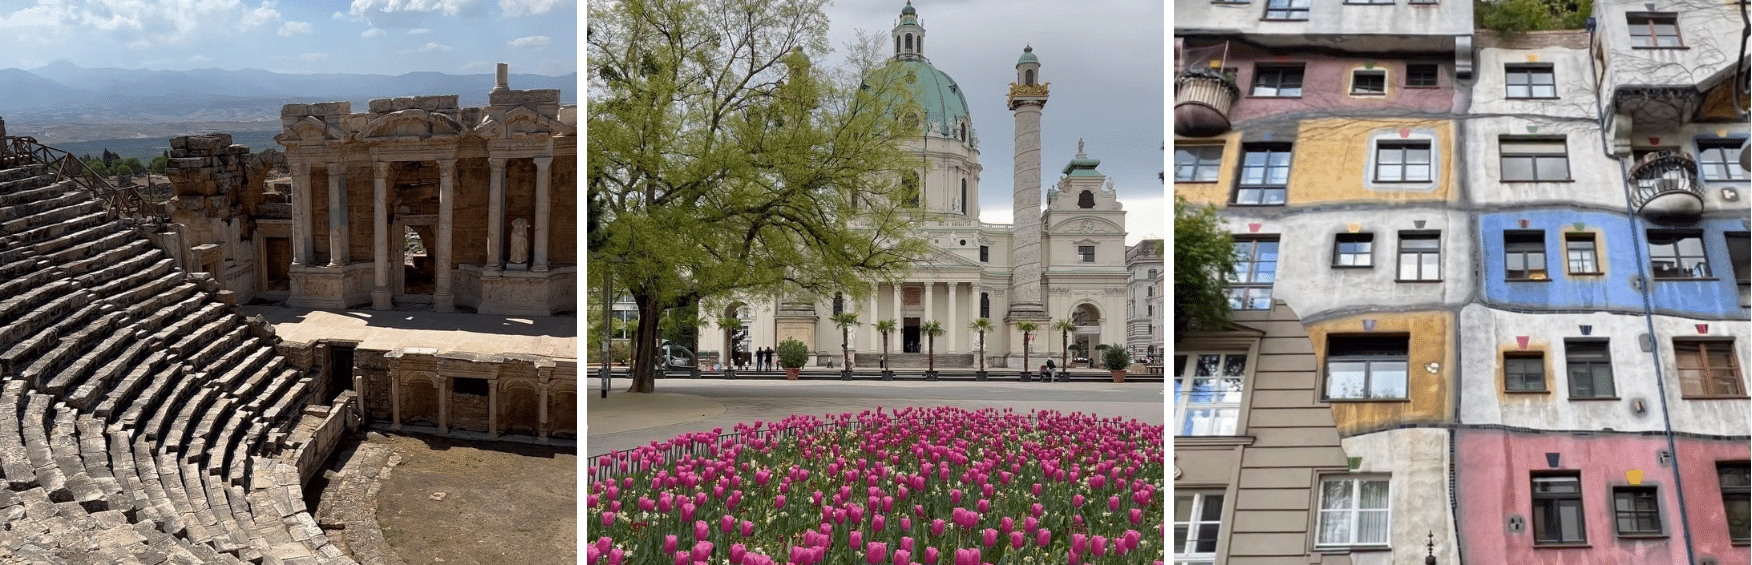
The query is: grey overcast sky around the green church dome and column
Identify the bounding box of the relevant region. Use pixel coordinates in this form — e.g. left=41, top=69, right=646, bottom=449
left=827, top=0, right=1169, bottom=244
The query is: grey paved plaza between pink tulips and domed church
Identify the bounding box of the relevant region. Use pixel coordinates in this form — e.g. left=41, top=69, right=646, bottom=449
left=580, top=377, right=1165, bottom=456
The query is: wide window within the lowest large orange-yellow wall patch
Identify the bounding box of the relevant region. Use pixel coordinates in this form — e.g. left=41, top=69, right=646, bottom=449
left=1326, top=335, right=1410, bottom=400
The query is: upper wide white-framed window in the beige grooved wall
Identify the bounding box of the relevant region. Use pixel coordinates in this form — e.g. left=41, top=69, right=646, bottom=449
left=1174, top=353, right=1247, bottom=435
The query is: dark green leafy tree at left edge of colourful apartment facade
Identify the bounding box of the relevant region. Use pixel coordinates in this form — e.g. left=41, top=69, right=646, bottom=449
left=1174, top=197, right=1235, bottom=337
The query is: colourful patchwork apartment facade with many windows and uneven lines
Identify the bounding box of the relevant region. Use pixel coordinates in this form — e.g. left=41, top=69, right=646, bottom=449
left=1170, top=0, right=1752, bottom=565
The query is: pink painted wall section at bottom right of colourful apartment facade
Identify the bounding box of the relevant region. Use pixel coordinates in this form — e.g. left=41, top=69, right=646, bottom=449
left=1456, top=430, right=1752, bottom=565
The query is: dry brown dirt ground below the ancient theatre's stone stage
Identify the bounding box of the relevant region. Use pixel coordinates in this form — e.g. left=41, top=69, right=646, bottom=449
left=318, top=432, right=578, bottom=565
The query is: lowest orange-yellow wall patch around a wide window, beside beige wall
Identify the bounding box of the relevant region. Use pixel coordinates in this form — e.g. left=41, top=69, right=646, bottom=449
left=1307, top=312, right=1459, bottom=437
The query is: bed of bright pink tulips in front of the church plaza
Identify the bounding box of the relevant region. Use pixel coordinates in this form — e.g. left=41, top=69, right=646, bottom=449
left=585, top=407, right=1165, bottom=565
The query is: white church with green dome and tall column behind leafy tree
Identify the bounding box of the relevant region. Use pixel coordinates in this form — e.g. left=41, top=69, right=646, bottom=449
left=699, top=2, right=1128, bottom=372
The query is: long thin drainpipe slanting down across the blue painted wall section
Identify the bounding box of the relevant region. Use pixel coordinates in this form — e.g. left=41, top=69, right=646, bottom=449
left=1587, top=19, right=1695, bottom=563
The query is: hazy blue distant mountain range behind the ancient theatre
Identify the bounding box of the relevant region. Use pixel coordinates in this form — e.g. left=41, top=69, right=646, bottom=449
left=0, top=61, right=578, bottom=123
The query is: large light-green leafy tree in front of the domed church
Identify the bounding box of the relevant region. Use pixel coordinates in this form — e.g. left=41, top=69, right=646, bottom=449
left=587, top=0, right=925, bottom=393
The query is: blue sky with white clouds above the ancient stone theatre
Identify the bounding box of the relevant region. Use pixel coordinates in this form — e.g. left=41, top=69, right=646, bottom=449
left=0, top=0, right=578, bottom=75
